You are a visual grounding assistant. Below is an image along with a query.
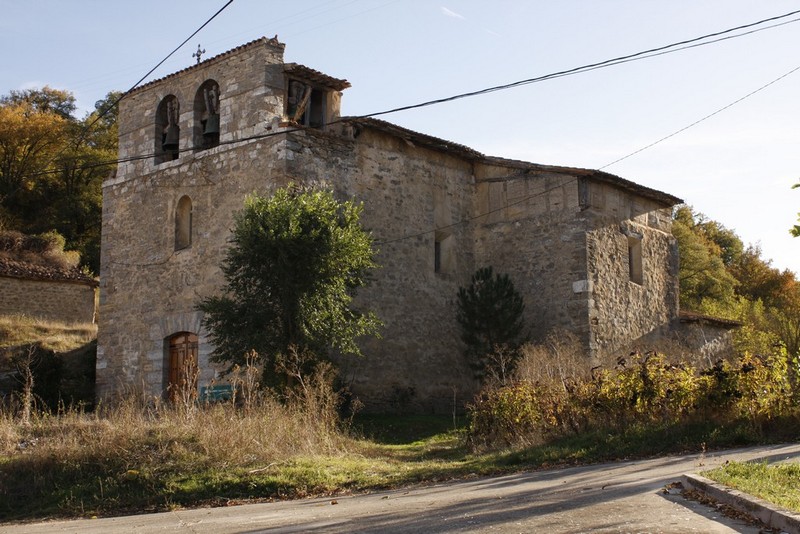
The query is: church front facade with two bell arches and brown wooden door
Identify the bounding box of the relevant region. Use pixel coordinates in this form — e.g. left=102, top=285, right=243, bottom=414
left=97, top=38, right=350, bottom=397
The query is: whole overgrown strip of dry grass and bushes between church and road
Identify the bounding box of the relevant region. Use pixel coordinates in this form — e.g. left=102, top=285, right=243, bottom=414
left=0, top=335, right=800, bottom=520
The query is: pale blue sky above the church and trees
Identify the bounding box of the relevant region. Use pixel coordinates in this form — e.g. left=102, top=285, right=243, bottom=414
left=0, top=0, right=800, bottom=273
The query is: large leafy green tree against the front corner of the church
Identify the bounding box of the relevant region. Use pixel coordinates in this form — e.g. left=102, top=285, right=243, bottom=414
left=198, top=186, right=380, bottom=385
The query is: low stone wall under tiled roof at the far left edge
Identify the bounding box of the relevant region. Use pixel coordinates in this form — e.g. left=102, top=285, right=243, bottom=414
left=0, top=276, right=96, bottom=323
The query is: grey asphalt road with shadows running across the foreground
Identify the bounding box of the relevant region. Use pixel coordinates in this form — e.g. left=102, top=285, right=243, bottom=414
left=0, top=444, right=800, bottom=534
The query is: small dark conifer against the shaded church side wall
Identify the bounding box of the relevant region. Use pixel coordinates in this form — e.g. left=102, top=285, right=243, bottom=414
left=456, top=267, right=525, bottom=379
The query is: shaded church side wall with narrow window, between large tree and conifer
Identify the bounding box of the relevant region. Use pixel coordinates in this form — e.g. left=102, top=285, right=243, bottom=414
left=328, top=125, right=475, bottom=413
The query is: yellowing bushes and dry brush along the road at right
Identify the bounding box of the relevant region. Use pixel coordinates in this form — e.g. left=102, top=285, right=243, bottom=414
left=469, top=338, right=800, bottom=449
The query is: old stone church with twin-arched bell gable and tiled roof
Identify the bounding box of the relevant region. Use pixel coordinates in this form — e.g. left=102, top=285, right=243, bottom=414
left=97, top=38, right=692, bottom=412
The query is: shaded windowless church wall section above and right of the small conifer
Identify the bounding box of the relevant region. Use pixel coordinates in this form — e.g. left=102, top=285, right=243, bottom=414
left=476, top=167, right=588, bottom=348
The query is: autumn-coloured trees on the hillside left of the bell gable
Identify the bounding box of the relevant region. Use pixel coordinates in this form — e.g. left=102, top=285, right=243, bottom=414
left=0, top=87, right=119, bottom=273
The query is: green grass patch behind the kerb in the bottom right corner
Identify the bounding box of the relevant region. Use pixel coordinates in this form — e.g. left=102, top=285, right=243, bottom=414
left=703, top=462, right=800, bottom=513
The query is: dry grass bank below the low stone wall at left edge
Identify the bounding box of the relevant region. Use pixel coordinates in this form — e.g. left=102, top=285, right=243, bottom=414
left=0, top=315, right=97, bottom=352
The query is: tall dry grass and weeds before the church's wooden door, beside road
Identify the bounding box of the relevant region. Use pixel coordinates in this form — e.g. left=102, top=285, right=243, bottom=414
left=0, top=370, right=355, bottom=520
